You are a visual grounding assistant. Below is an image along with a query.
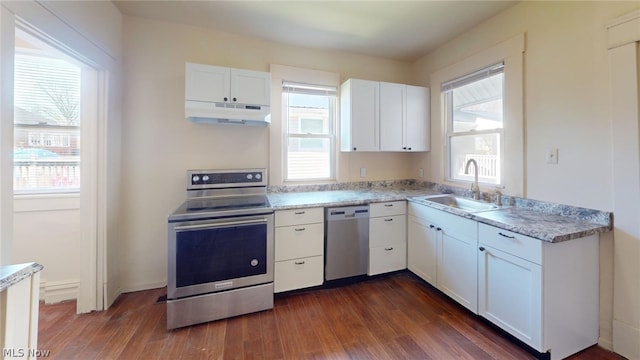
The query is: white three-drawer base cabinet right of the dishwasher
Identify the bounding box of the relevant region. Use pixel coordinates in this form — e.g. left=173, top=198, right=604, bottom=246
left=367, top=201, right=407, bottom=275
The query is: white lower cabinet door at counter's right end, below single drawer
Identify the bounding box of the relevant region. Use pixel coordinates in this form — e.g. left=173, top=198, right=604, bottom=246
left=478, top=243, right=543, bottom=351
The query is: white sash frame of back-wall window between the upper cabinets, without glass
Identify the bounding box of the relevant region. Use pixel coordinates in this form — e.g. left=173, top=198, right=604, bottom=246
left=282, top=81, right=338, bottom=183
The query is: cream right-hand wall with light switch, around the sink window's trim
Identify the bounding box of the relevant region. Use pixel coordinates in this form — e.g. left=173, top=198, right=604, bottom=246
left=414, top=1, right=638, bottom=348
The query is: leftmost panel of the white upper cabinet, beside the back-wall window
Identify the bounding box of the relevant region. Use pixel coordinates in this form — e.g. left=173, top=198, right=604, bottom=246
left=340, top=79, right=380, bottom=151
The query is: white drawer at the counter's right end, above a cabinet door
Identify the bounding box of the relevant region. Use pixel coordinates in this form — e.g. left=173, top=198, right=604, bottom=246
left=478, top=224, right=543, bottom=264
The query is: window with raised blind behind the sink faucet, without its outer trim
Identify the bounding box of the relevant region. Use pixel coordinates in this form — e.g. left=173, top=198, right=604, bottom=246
left=442, top=63, right=504, bottom=186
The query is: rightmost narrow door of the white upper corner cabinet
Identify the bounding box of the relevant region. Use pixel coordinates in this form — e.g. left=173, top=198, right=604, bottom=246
left=404, top=85, right=431, bottom=151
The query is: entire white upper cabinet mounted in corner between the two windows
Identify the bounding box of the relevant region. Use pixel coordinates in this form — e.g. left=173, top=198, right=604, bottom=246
left=340, top=79, right=430, bottom=151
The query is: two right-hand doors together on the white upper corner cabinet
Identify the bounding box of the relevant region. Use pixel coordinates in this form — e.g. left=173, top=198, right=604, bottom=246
left=380, top=82, right=430, bottom=151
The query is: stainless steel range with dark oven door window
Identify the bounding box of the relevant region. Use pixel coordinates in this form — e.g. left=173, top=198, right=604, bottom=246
left=167, top=169, right=274, bottom=329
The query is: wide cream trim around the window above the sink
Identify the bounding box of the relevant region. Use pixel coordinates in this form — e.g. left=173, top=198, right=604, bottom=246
left=430, top=34, right=526, bottom=196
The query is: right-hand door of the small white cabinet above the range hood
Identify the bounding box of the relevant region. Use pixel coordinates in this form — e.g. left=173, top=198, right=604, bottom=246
left=230, top=69, right=271, bottom=106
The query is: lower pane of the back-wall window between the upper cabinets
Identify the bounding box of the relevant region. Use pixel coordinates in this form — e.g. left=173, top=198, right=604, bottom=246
left=287, top=137, right=331, bottom=180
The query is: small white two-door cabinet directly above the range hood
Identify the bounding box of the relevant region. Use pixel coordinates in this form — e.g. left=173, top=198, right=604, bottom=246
left=185, top=63, right=271, bottom=106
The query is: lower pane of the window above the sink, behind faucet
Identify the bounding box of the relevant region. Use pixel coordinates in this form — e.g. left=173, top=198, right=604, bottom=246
left=449, top=134, right=501, bottom=184
